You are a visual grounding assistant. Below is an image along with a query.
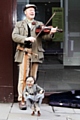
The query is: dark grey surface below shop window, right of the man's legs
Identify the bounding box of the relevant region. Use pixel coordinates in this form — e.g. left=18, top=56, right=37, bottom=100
left=37, top=64, right=80, bottom=92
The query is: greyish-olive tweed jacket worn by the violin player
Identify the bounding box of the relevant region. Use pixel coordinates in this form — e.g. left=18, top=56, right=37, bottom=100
left=12, top=19, right=52, bottom=63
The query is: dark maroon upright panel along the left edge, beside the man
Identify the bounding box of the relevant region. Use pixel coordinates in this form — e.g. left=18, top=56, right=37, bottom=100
left=0, top=0, right=15, bottom=102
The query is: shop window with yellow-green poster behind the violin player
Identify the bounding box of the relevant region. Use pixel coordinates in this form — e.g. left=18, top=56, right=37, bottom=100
left=17, top=0, right=80, bottom=67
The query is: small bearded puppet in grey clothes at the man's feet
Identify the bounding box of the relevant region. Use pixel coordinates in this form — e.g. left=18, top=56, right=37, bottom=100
left=23, top=76, right=45, bottom=116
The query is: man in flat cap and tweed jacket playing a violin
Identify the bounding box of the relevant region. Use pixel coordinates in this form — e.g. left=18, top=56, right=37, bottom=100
left=12, top=4, right=57, bottom=110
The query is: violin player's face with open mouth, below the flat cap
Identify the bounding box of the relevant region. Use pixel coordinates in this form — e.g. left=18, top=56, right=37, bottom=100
left=25, top=7, right=35, bottom=20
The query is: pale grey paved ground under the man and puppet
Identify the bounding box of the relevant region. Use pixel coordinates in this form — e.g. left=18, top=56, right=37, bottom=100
left=0, top=103, right=80, bottom=120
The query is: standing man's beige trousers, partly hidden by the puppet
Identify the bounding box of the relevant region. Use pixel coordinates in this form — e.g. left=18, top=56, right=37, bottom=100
left=18, top=54, right=38, bottom=101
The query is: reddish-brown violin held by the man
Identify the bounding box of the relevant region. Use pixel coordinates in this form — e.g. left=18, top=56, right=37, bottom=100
left=35, top=25, right=63, bottom=35
